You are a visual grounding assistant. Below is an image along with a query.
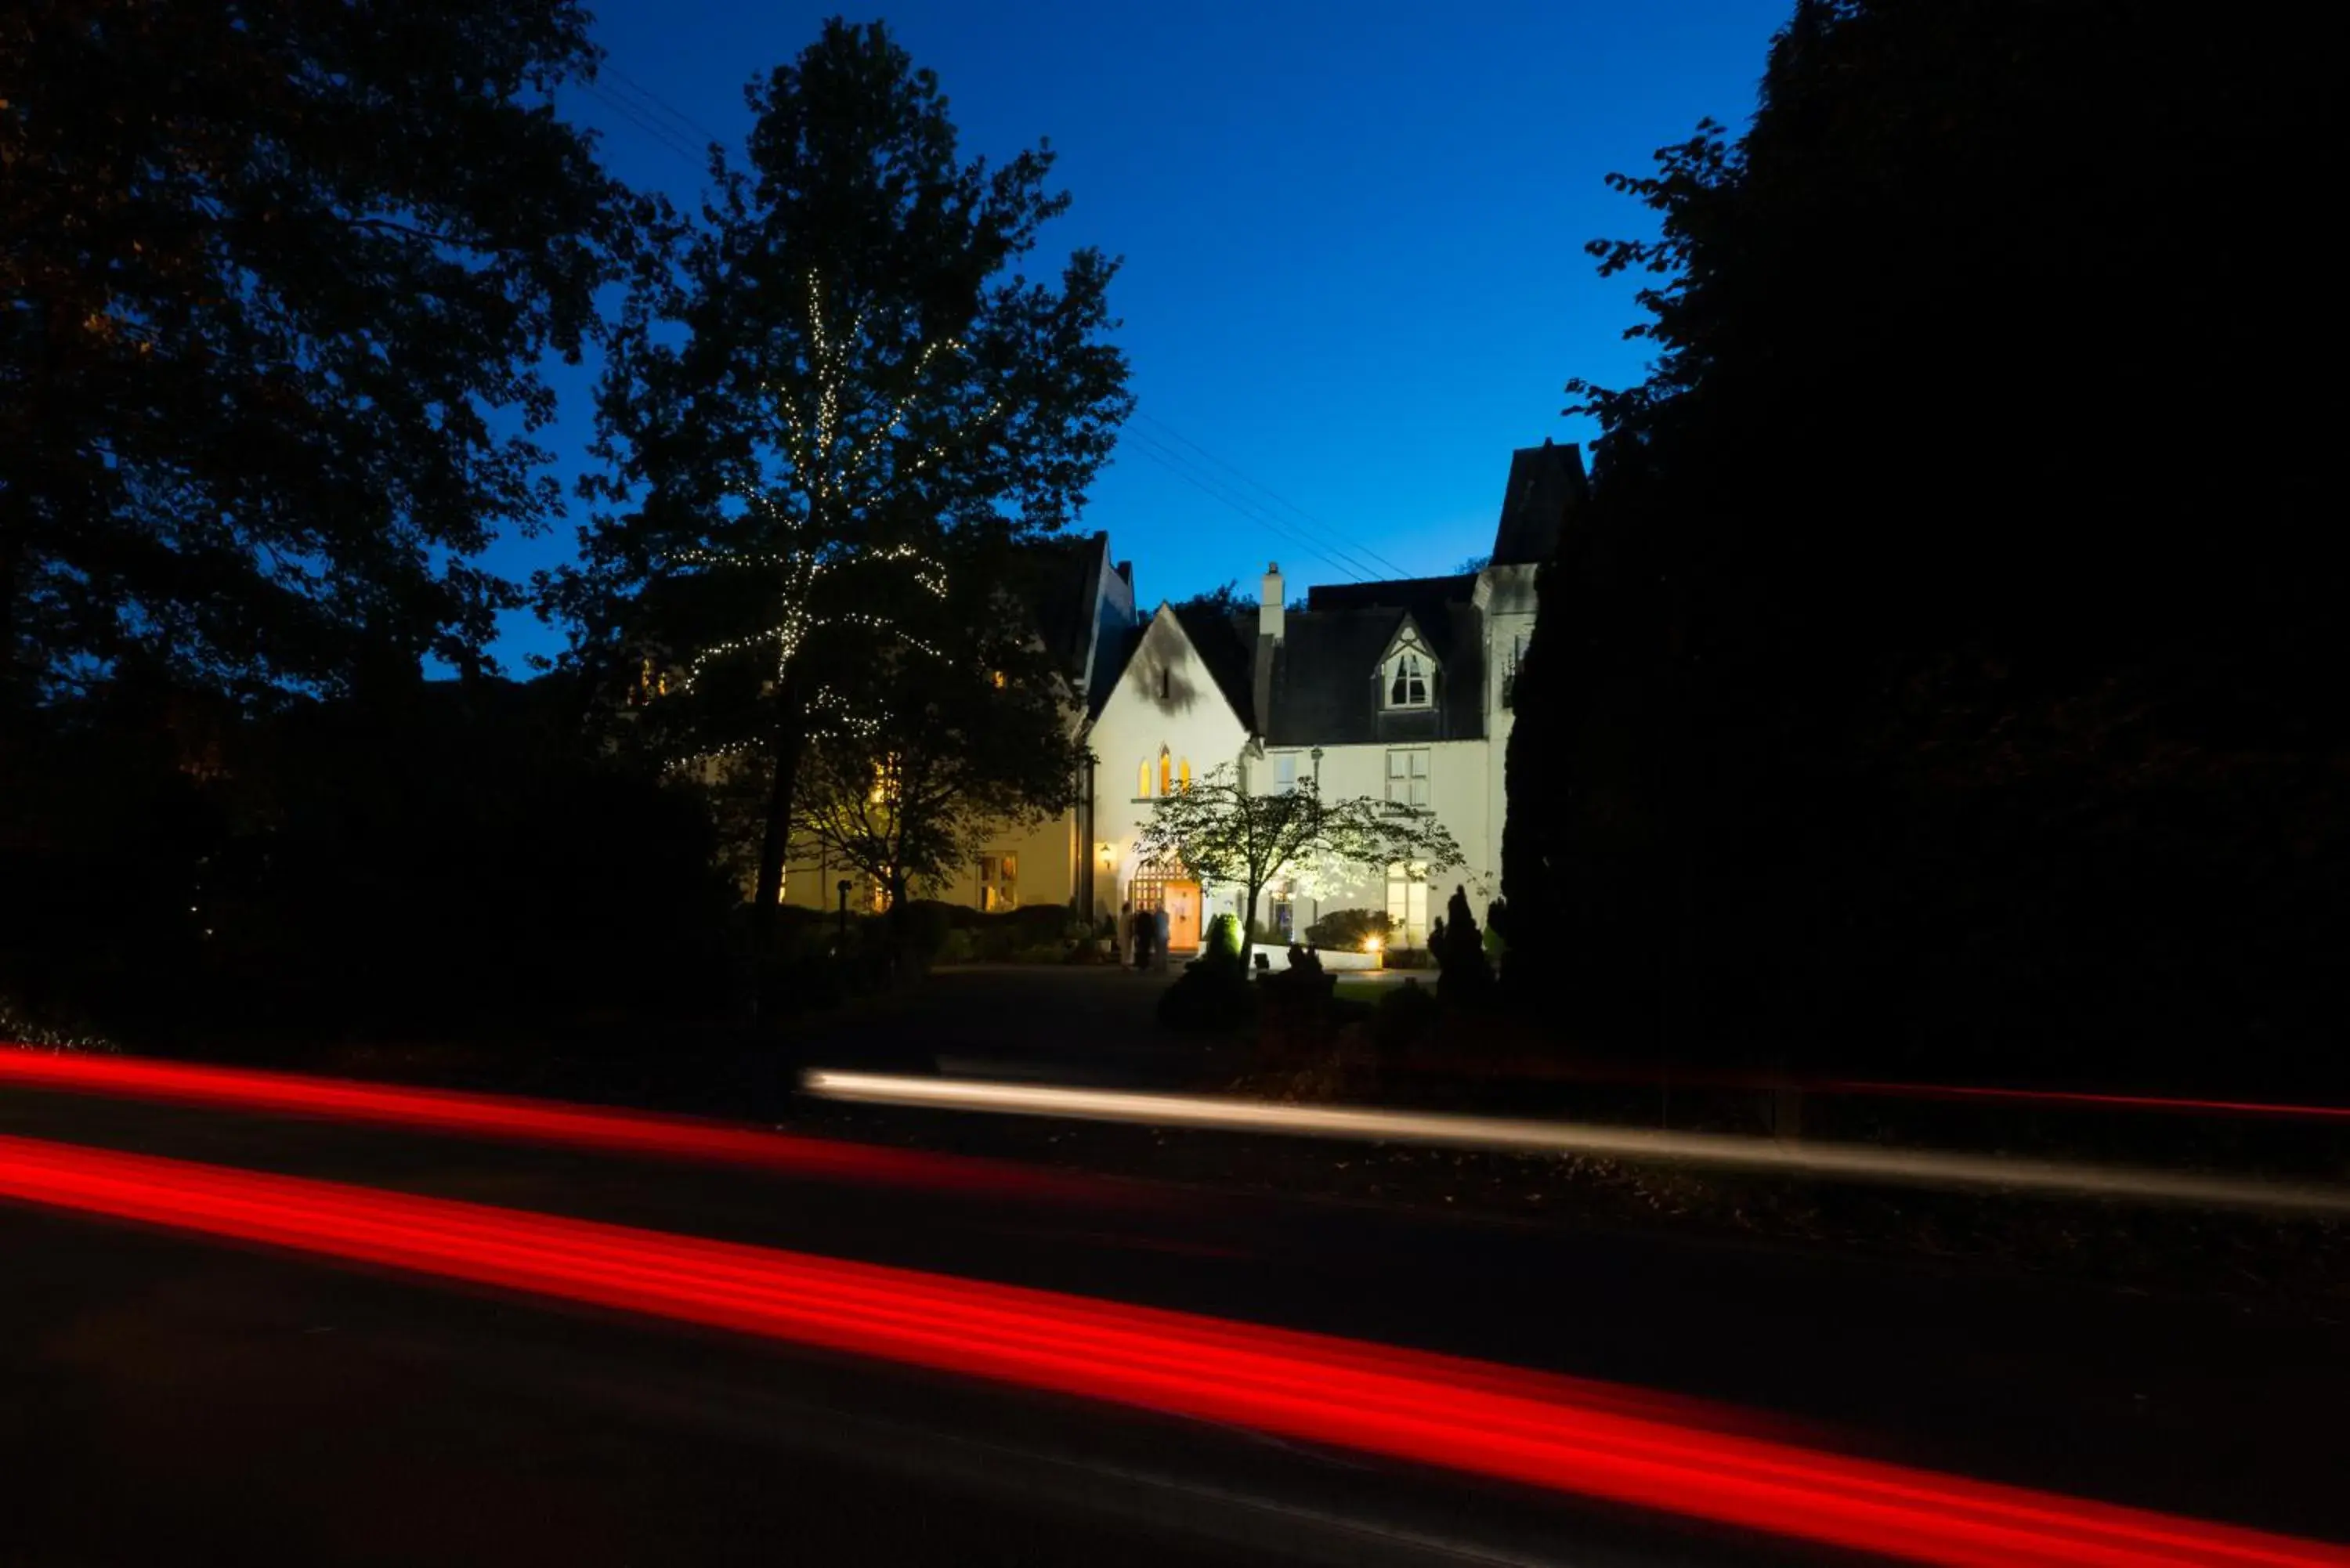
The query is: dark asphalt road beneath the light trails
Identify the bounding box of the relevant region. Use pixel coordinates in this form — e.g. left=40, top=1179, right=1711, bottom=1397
left=0, top=1093, right=2350, bottom=1563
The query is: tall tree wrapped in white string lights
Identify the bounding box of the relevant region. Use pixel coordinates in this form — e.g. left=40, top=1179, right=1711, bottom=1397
left=559, top=19, right=1133, bottom=968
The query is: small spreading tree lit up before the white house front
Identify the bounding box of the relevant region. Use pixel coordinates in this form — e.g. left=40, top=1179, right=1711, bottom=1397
left=1137, top=761, right=1466, bottom=962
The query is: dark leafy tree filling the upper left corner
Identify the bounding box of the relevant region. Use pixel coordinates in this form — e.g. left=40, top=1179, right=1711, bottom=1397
left=0, top=0, right=620, bottom=724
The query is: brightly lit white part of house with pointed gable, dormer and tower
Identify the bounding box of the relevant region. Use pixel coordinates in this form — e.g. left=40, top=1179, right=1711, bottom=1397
left=1081, top=442, right=1586, bottom=950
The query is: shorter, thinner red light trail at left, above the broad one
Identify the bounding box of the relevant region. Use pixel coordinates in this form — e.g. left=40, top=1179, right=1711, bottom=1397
left=0, top=1046, right=1081, bottom=1201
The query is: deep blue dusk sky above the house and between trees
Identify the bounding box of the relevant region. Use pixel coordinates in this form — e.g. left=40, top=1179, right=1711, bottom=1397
left=489, top=0, right=1788, bottom=658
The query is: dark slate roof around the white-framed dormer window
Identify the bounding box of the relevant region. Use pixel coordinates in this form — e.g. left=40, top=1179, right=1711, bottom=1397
left=1264, top=594, right=1485, bottom=745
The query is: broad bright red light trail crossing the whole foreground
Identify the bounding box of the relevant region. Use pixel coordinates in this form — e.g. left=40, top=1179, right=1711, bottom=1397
left=0, top=1138, right=2350, bottom=1568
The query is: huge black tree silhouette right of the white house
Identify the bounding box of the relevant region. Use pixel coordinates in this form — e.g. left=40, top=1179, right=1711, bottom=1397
left=1504, top=0, right=2350, bottom=1091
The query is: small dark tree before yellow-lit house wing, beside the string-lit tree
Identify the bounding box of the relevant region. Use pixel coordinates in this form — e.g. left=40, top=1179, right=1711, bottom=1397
left=794, top=562, right=1083, bottom=938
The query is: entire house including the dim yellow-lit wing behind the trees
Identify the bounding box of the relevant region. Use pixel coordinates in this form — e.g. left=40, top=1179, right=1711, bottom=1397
left=783, top=442, right=1584, bottom=950
